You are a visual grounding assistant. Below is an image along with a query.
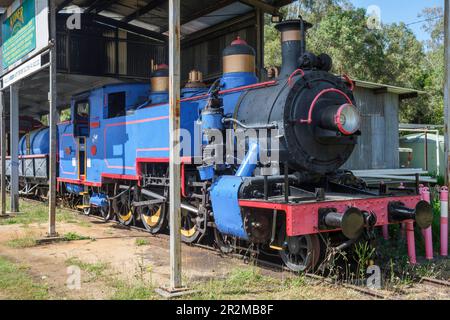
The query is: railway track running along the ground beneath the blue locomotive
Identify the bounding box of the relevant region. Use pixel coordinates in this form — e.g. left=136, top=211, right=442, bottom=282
left=15, top=198, right=450, bottom=300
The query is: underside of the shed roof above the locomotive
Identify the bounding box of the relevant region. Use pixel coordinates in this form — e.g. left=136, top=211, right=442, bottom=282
left=0, top=0, right=293, bottom=35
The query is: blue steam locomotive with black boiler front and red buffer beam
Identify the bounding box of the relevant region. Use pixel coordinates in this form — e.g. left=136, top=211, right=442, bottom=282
left=11, top=19, right=432, bottom=271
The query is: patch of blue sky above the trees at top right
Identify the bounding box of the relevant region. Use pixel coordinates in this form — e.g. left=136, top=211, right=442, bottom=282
left=350, top=0, right=444, bottom=40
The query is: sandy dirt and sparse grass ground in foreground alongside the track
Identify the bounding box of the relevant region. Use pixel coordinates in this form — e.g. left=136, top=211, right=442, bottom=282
left=0, top=201, right=450, bottom=299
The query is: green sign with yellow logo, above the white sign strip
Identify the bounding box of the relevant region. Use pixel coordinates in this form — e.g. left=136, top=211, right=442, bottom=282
left=2, top=0, right=36, bottom=69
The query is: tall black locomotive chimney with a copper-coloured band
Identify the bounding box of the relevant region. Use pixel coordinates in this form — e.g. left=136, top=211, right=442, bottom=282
left=276, top=17, right=312, bottom=78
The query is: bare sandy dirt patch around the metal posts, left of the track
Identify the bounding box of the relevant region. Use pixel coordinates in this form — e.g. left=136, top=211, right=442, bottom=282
left=0, top=216, right=246, bottom=299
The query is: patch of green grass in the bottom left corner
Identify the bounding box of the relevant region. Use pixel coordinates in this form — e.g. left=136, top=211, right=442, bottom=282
left=0, top=257, right=48, bottom=300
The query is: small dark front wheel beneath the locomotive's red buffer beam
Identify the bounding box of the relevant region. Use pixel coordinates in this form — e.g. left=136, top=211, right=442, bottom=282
left=280, top=235, right=320, bottom=272
